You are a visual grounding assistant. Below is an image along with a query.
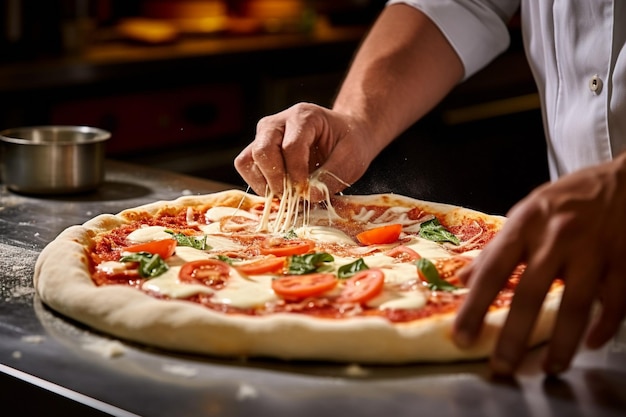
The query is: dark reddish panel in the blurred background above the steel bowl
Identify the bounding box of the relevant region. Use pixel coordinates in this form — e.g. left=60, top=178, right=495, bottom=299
left=51, top=84, right=243, bottom=155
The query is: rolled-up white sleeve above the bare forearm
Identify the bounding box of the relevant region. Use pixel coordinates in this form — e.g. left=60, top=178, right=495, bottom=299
left=387, top=0, right=520, bottom=79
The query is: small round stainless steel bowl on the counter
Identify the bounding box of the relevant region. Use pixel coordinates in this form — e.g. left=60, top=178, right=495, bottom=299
left=0, top=126, right=111, bottom=194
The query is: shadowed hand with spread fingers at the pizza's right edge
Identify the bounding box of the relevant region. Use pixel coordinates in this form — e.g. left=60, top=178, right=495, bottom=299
left=454, top=154, right=626, bottom=374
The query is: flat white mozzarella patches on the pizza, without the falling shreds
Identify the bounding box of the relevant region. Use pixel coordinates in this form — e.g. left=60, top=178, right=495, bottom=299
left=132, top=207, right=464, bottom=309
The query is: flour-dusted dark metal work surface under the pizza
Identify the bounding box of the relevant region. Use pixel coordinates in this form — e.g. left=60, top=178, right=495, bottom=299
left=0, top=162, right=626, bottom=417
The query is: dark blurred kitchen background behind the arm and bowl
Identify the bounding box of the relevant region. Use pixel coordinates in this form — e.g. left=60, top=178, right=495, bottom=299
left=0, top=0, right=547, bottom=212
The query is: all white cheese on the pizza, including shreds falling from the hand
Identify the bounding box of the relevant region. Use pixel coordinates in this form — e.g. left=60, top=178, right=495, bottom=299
left=108, top=177, right=480, bottom=309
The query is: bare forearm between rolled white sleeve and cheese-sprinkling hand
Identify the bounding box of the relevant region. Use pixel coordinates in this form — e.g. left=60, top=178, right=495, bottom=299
left=333, top=4, right=463, bottom=153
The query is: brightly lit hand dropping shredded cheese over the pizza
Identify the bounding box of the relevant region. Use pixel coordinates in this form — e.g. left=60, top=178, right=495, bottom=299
left=235, top=103, right=377, bottom=201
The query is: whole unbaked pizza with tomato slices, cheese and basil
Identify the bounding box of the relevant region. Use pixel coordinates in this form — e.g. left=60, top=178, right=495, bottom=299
left=34, top=190, right=563, bottom=364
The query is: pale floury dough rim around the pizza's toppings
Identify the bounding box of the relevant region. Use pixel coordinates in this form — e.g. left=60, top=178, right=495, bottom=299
left=34, top=191, right=561, bottom=364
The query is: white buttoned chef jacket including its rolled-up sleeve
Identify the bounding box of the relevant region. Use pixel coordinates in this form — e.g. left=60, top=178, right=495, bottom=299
left=387, top=0, right=626, bottom=179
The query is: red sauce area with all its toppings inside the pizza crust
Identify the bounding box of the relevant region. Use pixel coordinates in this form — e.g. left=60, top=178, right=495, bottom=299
left=89, top=190, right=516, bottom=323
